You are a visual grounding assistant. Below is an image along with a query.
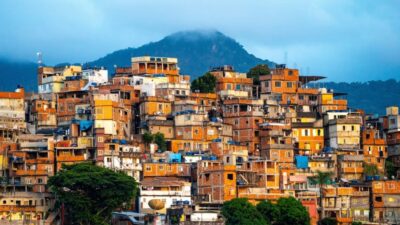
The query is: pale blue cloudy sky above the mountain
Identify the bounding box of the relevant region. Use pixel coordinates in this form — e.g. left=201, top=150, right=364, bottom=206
left=0, top=0, right=400, bottom=81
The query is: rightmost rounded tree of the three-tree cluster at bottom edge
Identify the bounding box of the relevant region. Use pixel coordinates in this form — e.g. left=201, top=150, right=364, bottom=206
left=275, top=197, right=310, bottom=225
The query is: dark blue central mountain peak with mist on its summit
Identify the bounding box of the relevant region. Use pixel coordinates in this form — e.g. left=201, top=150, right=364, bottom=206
left=89, top=30, right=274, bottom=76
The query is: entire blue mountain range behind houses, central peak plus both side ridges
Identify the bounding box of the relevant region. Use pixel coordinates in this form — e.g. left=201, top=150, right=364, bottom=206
left=0, top=30, right=400, bottom=114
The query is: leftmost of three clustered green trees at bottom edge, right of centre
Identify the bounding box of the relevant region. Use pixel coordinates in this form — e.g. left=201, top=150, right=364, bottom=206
left=221, top=198, right=267, bottom=225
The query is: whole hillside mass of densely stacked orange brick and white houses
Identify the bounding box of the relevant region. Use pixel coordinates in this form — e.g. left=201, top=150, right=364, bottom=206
left=0, top=56, right=400, bottom=224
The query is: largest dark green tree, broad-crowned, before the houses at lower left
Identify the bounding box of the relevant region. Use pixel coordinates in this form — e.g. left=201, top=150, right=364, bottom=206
left=48, top=163, right=137, bottom=225
